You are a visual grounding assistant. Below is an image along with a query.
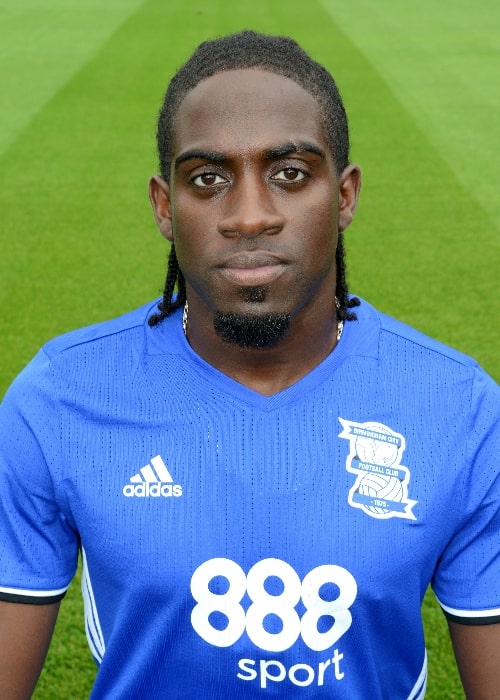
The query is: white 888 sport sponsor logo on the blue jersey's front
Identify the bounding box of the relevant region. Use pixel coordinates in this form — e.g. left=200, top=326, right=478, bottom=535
left=191, top=558, right=357, bottom=688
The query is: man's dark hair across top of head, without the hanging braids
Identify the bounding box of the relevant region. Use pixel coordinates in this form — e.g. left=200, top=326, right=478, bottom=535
left=157, top=31, right=349, bottom=182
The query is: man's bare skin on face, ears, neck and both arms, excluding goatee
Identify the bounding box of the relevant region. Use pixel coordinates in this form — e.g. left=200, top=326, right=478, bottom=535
left=0, top=70, right=500, bottom=700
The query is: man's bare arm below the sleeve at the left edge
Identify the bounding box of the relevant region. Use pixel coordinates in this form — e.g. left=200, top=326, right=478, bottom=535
left=0, top=601, right=59, bottom=700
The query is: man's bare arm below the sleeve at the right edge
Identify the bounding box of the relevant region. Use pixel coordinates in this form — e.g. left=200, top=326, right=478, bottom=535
left=448, top=620, right=500, bottom=700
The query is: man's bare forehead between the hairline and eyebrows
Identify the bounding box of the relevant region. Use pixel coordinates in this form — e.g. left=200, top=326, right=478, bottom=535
left=173, top=68, right=329, bottom=157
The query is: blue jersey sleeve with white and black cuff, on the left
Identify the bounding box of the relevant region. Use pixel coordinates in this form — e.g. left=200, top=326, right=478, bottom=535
left=0, top=352, right=78, bottom=604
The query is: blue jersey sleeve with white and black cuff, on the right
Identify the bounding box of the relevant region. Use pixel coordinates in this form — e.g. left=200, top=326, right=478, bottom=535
left=433, top=372, right=500, bottom=625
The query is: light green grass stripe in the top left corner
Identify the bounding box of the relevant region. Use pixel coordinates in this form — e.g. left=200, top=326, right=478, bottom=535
left=0, top=0, right=146, bottom=153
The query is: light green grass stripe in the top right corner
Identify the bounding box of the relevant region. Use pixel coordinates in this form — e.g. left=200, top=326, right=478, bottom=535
left=322, top=0, right=500, bottom=228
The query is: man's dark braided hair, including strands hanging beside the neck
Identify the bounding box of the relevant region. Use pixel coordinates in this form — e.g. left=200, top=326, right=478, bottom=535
left=149, top=30, right=359, bottom=326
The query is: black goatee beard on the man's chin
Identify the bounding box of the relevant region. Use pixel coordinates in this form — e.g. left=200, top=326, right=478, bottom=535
left=214, top=311, right=290, bottom=349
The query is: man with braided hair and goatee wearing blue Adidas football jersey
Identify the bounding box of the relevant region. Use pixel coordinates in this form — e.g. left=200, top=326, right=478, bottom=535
left=0, top=32, right=500, bottom=700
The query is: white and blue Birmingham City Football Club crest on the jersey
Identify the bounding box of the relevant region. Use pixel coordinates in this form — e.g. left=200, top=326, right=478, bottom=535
left=339, top=418, right=417, bottom=520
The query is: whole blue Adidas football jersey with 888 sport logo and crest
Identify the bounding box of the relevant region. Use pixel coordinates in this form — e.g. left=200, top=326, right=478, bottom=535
left=0, top=301, right=500, bottom=700
